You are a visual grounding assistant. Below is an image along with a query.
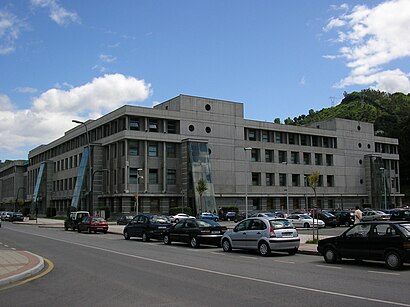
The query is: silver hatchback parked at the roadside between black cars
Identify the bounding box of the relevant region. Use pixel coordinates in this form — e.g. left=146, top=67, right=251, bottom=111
left=221, top=217, right=300, bottom=256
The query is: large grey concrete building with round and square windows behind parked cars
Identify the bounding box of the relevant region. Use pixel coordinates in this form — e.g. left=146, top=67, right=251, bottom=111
left=27, top=95, right=403, bottom=215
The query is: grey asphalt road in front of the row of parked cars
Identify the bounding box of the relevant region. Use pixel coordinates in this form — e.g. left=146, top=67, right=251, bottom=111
left=0, top=223, right=410, bottom=307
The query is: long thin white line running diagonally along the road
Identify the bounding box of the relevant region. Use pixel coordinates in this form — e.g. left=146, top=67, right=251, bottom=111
left=7, top=229, right=410, bottom=307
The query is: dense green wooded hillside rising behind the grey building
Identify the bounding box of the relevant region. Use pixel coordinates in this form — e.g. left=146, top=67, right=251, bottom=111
left=285, top=89, right=410, bottom=202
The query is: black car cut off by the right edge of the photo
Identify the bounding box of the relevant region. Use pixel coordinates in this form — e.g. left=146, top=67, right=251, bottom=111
left=317, top=221, right=410, bottom=270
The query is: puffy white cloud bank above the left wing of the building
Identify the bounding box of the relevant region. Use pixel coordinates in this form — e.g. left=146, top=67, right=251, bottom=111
left=0, top=74, right=151, bottom=158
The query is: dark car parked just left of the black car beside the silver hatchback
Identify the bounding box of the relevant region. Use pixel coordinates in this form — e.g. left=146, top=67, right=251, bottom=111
left=123, top=214, right=172, bottom=242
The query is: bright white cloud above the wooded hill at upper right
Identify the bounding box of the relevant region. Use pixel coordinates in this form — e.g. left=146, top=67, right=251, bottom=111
left=324, top=0, right=410, bottom=93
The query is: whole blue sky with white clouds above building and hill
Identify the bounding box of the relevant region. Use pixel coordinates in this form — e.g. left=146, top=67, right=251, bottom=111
left=0, top=0, right=410, bottom=161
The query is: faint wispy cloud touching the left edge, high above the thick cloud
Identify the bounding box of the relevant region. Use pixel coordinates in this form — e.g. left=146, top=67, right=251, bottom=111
left=0, top=10, right=26, bottom=55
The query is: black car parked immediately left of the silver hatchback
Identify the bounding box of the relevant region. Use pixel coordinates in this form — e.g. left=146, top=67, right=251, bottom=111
left=164, top=219, right=227, bottom=248
